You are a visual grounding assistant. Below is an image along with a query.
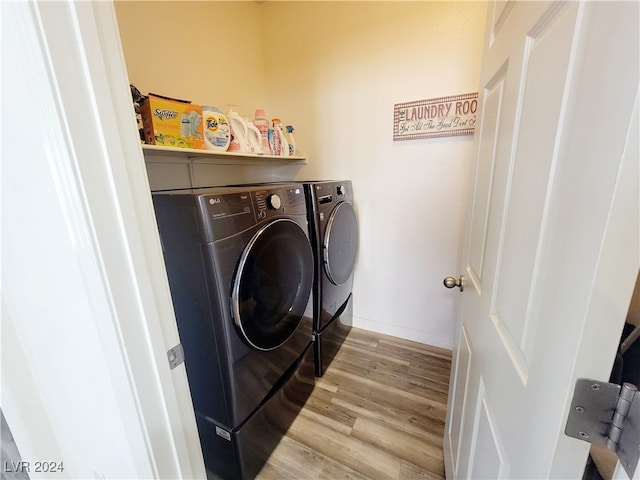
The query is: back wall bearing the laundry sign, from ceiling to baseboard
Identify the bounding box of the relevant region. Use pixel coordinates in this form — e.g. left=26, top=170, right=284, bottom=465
left=261, top=2, right=486, bottom=346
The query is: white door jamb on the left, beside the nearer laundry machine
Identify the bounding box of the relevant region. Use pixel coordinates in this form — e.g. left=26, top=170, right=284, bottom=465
left=60, top=2, right=205, bottom=478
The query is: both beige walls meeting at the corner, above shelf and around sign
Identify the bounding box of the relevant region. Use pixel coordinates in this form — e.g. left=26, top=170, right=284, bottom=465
left=116, top=1, right=486, bottom=347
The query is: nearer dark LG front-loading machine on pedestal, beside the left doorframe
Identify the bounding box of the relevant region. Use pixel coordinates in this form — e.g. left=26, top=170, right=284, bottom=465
left=152, top=183, right=315, bottom=479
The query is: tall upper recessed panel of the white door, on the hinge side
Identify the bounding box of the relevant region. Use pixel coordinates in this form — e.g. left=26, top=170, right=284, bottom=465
left=490, top=0, right=577, bottom=384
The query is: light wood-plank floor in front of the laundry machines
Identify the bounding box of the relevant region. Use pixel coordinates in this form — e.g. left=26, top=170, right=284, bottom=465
left=257, top=328, right=451, bottom=480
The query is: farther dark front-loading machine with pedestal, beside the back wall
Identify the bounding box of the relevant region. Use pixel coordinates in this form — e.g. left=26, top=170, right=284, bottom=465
left=304, top=180, right=358, bottom=377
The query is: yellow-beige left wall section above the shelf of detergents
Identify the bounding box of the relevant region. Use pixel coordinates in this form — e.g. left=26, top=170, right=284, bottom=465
left=114, top=1, right=265, bottom=112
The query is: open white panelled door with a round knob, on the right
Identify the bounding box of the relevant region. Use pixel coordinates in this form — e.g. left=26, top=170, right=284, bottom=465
left=445, top=2, right=640, bottom=479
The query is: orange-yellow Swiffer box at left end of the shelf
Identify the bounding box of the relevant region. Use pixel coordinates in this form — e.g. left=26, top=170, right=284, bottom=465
left=140, top=93, right=204, bottom=148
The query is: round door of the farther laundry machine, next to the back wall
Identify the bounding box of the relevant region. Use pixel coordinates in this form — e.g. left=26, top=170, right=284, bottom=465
left=323, top=202, right=358, bottom=285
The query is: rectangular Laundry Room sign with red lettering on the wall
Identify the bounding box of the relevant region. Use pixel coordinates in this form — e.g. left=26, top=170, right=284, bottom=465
left=393, top=92, right=478, bottom=141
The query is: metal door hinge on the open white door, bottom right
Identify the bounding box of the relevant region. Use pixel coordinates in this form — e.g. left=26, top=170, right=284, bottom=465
left=564, top=378, right=640, bottom=478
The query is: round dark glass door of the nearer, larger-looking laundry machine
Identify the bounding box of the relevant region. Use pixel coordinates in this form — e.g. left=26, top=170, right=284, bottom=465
left=231, top=219, right=313, bottom=350
